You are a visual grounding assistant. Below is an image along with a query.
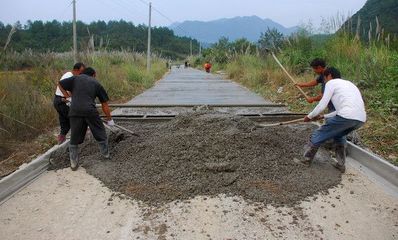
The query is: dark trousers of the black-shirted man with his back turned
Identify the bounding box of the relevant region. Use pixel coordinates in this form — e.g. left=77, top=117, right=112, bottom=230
left=69, top=116, right=107, bottom=145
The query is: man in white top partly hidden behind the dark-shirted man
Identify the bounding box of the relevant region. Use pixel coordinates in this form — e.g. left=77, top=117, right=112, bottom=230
left=53, top=63, right=85, bottom=144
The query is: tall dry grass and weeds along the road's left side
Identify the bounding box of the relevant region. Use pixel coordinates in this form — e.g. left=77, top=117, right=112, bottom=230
left=0, top=51, right=167, bottom=178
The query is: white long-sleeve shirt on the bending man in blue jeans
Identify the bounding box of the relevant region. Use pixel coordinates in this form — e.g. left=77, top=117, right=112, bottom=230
left=308, top=78, right=366, bottom=122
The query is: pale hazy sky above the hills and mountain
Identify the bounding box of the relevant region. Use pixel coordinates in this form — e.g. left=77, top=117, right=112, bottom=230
left=0, top=0, right=366, bottom=27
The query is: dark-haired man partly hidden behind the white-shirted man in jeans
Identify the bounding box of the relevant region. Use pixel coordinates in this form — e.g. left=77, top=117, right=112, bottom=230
left=296, top=58, right=335, bottom=112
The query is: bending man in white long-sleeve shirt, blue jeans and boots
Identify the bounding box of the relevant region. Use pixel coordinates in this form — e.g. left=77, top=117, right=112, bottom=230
left=300, top=67, right=366, bottom=173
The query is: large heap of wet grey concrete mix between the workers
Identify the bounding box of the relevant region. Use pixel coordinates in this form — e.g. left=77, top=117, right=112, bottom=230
left=53, top=112, right=341, bottom=205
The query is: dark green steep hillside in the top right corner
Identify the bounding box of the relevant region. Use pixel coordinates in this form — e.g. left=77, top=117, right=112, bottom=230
left=343, top=0, right=398, bottom=38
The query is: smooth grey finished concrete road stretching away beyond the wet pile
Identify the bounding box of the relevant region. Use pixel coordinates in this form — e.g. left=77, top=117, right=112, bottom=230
left=127, top=68, right=271, bottom=105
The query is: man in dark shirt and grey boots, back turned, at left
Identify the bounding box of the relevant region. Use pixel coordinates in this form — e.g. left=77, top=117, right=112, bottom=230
left=58, top=67, right=115, bottom=171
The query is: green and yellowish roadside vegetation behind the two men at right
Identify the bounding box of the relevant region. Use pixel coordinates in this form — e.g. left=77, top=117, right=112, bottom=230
left=196, top=33, right=398, bottom=165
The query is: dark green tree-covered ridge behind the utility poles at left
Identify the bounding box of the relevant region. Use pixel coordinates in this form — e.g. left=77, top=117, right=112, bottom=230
left=0, top=20, right=199, bottom=58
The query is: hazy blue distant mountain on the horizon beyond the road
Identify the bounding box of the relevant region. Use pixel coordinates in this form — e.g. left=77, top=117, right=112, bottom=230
left=169, top=16, right=298, bottom=43
